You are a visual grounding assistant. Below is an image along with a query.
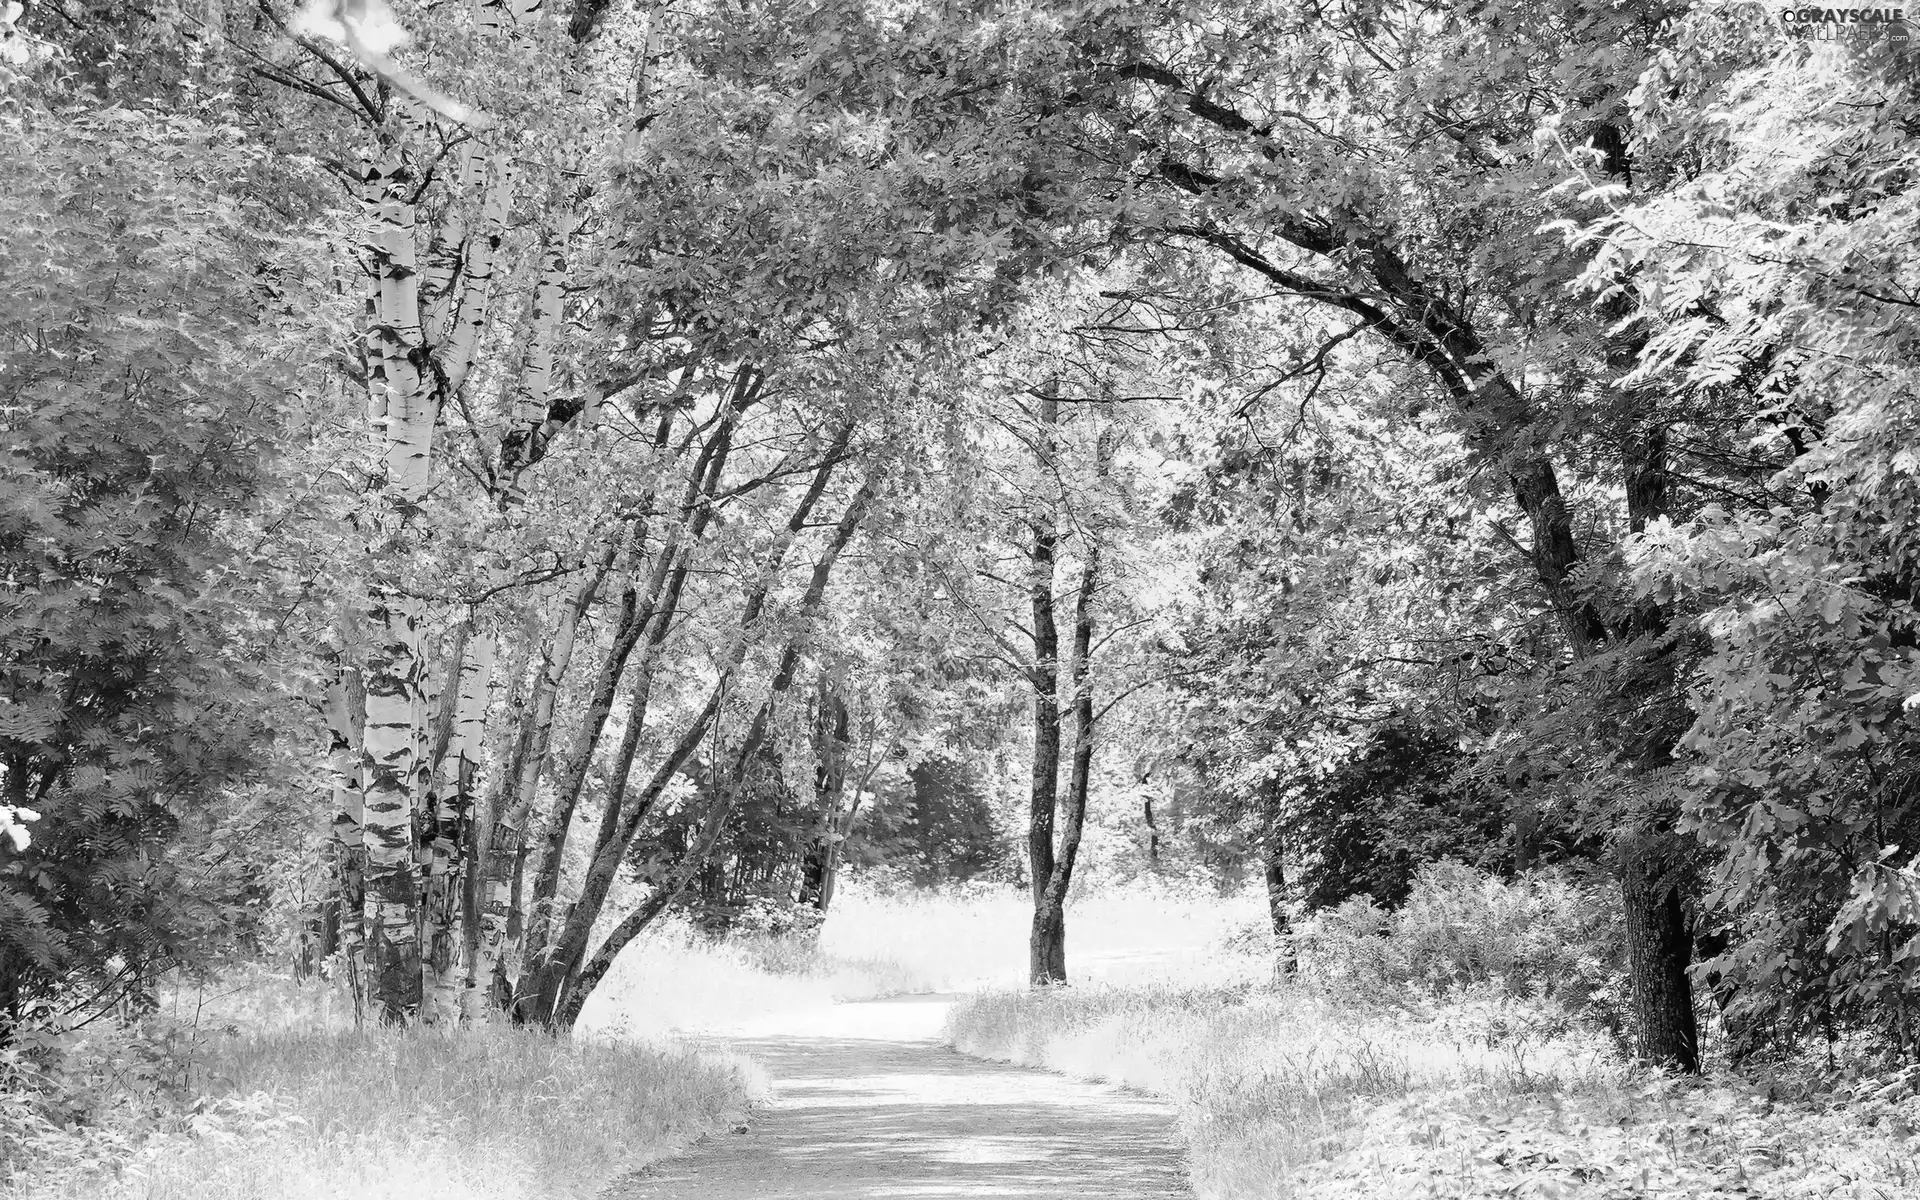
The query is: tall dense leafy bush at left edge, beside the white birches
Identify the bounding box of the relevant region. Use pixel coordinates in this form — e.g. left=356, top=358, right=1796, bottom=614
left=0, top=67, right=336, bottom=1021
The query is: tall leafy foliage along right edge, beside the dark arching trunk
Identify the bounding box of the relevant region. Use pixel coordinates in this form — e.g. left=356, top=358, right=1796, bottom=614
left=1574, top=16, right=1920, bottom=1058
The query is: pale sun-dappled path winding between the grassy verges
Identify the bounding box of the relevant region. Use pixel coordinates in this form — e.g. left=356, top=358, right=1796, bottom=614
left=607, top=996, right=1188, bottom=1200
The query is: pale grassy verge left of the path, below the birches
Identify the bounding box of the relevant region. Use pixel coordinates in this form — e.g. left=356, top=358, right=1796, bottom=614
left=0, top=963, right=764, bottom=1200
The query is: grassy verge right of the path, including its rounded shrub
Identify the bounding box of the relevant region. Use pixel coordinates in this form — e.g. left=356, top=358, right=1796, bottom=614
left=948, top=872, right=1920, bottom=1200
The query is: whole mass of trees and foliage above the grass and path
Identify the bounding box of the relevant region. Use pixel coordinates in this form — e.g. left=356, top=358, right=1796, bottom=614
left=0, top=0, right=1920, bottom=1069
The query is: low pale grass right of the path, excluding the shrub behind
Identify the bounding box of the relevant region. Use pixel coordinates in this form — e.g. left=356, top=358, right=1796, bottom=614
left=948, top=987, right=1920, bottom=1200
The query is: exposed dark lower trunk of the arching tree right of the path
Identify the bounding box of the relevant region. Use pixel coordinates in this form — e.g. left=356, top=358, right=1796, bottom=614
left=1619, top=839, right=1699, bottom=1075
